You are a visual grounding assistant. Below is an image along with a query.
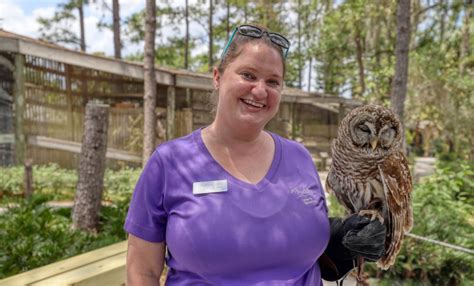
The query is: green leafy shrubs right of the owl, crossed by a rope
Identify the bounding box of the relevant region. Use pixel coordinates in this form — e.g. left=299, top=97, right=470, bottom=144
left=368, top=161, right=474, bottom=285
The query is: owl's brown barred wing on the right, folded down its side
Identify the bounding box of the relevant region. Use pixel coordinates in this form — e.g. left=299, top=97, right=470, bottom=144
left=377, top=151, right=413, bottom=269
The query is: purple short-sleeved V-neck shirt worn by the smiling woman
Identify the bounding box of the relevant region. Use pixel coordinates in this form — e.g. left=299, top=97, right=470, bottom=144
left=125, top=130, right=329, bottom=286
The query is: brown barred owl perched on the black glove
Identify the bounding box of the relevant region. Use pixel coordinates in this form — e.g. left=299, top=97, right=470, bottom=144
left=326, top=105, right=413, bottom=271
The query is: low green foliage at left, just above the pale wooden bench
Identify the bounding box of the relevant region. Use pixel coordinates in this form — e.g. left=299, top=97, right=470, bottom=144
left=0, top=195, right=128, bottom=279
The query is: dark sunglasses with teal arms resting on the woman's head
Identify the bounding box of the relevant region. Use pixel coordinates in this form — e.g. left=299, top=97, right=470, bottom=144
left=221, top=25, right=290, bottom=61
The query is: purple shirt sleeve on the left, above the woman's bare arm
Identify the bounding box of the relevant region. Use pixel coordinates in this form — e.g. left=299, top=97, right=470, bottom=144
left=124, top=151, right=168, bottom=242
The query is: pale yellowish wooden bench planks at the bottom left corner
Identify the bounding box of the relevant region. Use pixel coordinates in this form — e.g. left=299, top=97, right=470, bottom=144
left=0, top=241, right=127, bottom=286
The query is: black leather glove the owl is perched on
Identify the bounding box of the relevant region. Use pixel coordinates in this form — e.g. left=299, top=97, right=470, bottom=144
left=319, top=214, right=386, bottom=281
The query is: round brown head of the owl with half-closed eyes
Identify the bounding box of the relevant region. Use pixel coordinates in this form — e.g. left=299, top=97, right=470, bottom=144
left=342, top=105, right=402, bottom=154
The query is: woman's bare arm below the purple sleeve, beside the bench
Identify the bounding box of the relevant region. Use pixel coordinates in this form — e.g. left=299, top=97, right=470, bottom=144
left=127, top=234, right=165, bottom=286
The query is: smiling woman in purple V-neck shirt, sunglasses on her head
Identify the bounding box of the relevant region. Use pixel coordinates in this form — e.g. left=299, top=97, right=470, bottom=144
left=125, top=25, right=384, bottom=285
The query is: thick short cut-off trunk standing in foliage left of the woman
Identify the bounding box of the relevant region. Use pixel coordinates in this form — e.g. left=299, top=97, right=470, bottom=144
left=72, top=103, right=109, bottom=233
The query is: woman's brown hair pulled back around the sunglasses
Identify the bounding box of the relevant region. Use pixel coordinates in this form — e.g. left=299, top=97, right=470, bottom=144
left=217, top=24, right=286, bottom=77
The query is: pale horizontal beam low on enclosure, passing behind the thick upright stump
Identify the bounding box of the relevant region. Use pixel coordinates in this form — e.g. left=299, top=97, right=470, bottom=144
left=28, top=136, right=142, bottom=163
